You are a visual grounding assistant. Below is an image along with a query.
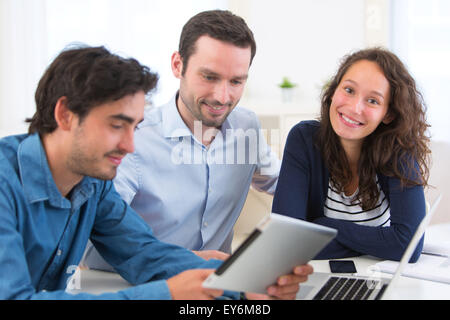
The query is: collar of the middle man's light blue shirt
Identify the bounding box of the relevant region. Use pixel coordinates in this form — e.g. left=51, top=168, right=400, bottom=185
left=161, top=92, right=233, bottom=138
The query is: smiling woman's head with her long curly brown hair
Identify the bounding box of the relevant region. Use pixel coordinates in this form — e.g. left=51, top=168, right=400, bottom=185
left=319, top=49, right=430, bottom=208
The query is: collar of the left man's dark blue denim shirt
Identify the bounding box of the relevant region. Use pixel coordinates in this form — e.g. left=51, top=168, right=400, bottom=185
left=17, top=133, right=98, bottom=208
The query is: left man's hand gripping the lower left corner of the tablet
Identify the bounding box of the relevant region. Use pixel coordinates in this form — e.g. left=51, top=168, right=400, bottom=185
left=167, top=269, right=223, bottom=300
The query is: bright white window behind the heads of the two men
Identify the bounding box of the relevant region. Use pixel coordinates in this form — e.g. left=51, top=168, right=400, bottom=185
left=45, top=0, right=228, bottom=105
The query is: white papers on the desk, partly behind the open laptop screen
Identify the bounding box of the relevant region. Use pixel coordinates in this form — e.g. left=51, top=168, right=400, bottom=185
left=372, top=254, right=450, bottom=284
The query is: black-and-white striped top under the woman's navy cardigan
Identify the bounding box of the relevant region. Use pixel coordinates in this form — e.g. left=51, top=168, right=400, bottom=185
left=324, top=181, right=391, bottom=227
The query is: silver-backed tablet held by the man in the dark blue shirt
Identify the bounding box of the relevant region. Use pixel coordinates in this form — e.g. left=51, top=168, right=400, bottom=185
left=203, top=213, right=337, bottom=293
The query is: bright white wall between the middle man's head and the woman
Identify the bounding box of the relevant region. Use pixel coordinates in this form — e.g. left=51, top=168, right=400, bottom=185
left=231, top=0, right=365, bottom=112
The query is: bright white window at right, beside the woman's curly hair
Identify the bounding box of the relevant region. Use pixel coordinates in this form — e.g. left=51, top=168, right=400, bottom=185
left=391, top=0, right=450, bottom=142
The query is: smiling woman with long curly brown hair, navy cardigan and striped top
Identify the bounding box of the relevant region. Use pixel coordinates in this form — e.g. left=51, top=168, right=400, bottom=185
left=272, top=48, right=430, bottom=261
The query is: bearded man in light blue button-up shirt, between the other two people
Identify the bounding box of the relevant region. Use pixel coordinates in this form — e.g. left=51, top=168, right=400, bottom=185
left=86, top=10, right=280, bottom=269
